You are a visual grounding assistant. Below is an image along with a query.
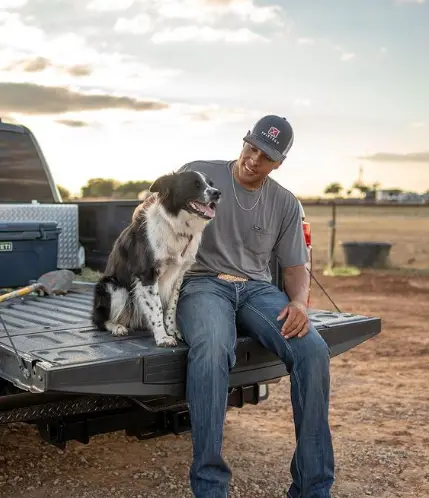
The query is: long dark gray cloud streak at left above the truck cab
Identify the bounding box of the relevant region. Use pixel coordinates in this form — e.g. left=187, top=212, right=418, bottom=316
left=0, top=83, right=168, bottom=115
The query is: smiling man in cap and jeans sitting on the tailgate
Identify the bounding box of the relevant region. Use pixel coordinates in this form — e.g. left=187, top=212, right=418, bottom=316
left=177, top=115, right=334, bottom=498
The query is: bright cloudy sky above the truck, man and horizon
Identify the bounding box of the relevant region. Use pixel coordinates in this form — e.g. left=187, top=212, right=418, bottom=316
left=0, top=0, right=429, bottom=196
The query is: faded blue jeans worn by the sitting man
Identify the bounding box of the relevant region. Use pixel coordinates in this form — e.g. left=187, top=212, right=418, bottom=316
left=177, top=277, right=334, bottom=498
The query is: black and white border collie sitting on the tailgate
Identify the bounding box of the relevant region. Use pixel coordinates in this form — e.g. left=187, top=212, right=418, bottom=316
left=92, top=171, right=221, bottom=347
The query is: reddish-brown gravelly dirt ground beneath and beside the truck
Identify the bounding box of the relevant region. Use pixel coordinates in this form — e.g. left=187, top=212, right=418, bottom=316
left=0, top=272, right=429, bottom=498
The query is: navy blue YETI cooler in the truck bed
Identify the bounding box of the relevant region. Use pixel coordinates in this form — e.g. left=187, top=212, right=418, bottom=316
left=0, top=221, right=61, bottom=288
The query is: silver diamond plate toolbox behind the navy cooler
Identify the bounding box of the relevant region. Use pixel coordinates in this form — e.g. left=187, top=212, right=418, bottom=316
left=0, top=203, right=85, bottom=270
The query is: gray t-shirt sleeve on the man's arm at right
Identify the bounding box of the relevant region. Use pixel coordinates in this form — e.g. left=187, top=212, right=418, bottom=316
left=274, top=197, right=309, bottom=268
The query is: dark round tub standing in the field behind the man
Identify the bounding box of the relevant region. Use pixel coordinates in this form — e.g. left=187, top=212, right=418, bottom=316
left=342, top=242, right=392, bottom=268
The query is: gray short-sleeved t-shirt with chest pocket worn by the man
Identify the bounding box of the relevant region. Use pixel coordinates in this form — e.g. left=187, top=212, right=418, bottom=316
left=179, top=161, right=308, bottom=282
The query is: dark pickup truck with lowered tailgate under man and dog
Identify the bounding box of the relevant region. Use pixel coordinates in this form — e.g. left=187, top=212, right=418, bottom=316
left=0, top=120, right=381, bottom=448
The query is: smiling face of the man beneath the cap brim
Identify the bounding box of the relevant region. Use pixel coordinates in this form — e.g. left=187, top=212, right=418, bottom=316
left=237, top=142, right=281, bottom=188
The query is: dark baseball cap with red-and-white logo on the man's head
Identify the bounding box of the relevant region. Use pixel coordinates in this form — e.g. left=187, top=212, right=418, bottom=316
left=243, top=114, right=294, bottom=162
